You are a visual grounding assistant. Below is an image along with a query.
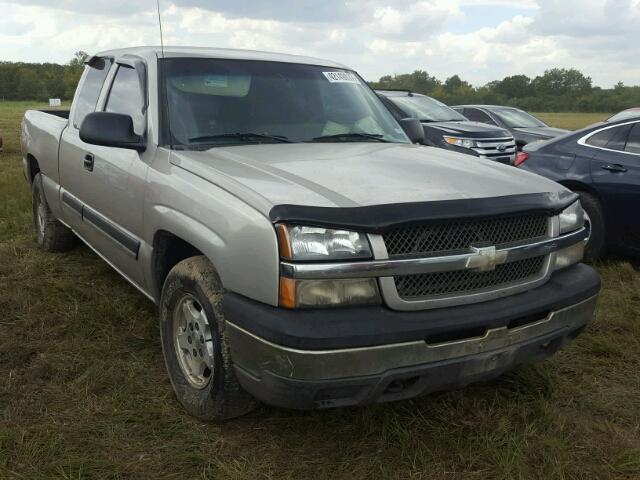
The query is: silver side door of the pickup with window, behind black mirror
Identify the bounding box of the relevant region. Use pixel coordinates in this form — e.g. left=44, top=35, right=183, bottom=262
left=60, top=60, right=148, bottom=286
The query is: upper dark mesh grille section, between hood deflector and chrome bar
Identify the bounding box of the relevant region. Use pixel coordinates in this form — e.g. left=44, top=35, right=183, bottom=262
left=383, top=214, right=549, bottom=258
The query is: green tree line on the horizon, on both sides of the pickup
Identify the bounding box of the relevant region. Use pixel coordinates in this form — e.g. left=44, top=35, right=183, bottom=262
left=0, top=51, right=640, bottom=112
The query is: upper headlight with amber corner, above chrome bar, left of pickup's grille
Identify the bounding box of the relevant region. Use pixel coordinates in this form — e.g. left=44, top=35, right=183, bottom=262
left=277, top=225, right=372, bottom=261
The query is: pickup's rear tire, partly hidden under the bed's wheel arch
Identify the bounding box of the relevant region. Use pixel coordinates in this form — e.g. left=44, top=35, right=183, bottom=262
left=31, top=172, right=78, bottom=252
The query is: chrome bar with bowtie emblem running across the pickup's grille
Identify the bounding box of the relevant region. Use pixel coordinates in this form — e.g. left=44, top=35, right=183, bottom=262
left=280, top=228, right=587, bottom=279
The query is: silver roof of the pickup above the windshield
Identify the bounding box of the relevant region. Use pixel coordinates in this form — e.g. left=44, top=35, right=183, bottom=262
left=91, top=45, right=353, bottom=70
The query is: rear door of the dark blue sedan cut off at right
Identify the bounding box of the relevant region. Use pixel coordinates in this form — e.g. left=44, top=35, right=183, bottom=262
left=586, top=122, right=640, bottom=249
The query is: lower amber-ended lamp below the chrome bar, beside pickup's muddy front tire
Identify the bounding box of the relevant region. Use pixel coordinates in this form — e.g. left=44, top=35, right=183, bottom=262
left=279, top=277, right=380, bottom=308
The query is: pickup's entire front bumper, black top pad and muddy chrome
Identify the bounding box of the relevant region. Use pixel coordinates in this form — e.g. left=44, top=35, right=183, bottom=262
left=223, top=264, right=600, bottom=409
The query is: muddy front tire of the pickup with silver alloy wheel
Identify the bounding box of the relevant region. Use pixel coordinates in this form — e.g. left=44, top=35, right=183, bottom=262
left=160, top=256, right=256, bottom=421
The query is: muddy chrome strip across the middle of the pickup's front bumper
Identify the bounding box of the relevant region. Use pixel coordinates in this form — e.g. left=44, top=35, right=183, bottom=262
left=226, top=295, right=597, bottom=381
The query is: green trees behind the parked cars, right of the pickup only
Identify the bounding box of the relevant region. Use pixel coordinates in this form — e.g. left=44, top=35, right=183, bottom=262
left=370, top=68, right=640, bottom=112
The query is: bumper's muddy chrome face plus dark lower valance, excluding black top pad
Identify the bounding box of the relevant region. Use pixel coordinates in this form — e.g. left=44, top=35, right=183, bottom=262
left=227, top=296, right=596, bottom=409
